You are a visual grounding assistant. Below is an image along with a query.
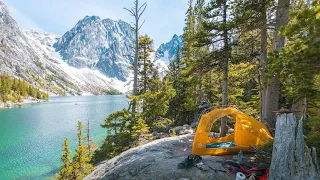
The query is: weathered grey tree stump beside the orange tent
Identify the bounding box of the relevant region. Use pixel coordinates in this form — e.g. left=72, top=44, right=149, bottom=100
left=269, top=113, right=320, bottom=180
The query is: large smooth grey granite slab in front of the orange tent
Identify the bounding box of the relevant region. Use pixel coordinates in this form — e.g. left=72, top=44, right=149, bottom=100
left=85, top=135, right=235, bottom=180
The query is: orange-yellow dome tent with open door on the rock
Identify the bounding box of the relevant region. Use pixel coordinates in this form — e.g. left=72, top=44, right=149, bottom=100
left=192, top=107, right=273, bottom=156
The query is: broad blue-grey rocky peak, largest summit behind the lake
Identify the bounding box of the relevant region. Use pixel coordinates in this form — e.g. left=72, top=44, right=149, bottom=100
left=54, top=16, right=134, bottom=81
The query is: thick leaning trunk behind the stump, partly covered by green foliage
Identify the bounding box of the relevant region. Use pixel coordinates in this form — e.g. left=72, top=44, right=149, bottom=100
left=263, top=0, right=290, bottom=128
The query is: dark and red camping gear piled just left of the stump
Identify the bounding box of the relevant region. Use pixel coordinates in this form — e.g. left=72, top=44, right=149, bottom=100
left=222, top=160, right=269, bottom=180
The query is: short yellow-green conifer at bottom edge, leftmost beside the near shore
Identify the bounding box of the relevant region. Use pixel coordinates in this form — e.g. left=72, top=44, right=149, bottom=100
left=56, top=138, right=73, bottom=180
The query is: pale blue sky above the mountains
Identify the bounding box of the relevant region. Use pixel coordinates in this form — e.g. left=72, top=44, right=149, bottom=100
left=3, top=0, right=187, bottom=46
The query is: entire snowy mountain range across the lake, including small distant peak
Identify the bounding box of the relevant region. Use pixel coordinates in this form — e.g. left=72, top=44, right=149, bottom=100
left=0, top=0, right=183, bottom=95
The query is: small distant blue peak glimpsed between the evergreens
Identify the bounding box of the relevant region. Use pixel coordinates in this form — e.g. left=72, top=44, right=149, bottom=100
left=155, top=34, right=183, bottom=65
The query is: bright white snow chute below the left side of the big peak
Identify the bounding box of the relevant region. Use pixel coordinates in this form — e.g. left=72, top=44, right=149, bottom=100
left=24, top=30, right=130, bottom=94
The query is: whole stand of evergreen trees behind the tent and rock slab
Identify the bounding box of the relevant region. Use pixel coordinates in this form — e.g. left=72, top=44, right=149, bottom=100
left=55, top=0, right=320, bottom=179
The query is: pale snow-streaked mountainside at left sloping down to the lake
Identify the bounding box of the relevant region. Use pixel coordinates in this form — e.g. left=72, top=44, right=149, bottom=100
left=0, top=1, right=127, bottom=94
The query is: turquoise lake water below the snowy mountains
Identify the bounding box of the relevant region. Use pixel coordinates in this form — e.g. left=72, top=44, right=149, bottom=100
left=0, top=96, right=128, bottom=180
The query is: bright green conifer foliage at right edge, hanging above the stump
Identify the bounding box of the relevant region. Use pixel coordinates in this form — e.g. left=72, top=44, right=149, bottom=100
left=266, top=1, right=320, bottom=108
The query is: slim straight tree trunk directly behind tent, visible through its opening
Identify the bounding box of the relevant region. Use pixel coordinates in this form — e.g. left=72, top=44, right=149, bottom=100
left=220, top=0, right=229, bottom=137
